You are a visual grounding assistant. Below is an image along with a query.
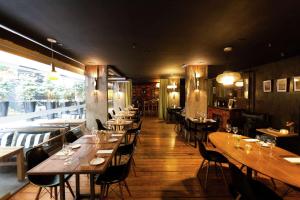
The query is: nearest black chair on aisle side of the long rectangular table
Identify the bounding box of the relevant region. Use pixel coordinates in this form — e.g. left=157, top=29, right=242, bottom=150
left=96, top=155, right=132, bottom=199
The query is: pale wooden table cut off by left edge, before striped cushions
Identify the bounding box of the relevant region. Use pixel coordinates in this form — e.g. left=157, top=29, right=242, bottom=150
left=0, top=147, right=25, bottom=181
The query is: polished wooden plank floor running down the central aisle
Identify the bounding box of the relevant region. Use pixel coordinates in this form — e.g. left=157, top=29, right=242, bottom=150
left=11, top=118, right=300, bottom=200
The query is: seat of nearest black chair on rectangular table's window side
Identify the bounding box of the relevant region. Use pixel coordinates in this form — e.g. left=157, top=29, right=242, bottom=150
left=28, top=174, right=72, bottom=187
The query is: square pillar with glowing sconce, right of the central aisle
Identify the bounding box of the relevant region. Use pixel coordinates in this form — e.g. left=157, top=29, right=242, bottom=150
left=185, top=65, right=207, bottom=117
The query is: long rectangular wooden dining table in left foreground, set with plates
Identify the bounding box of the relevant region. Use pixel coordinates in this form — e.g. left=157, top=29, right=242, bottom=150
left=27, top=132, right=125, bottom=200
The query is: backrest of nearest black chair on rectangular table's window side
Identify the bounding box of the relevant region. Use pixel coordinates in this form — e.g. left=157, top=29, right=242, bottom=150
left=26, top=147, right=49, bottom=170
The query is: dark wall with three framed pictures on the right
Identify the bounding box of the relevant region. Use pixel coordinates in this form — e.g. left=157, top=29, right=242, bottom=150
left=254, top=56, right=300, bottom=132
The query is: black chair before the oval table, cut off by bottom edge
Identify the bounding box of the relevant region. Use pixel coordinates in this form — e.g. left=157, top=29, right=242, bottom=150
left=229, top=163, right=282, bottom=200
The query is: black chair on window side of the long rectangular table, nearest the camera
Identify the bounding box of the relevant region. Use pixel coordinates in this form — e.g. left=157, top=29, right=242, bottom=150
left=26, top=147, right=75, bottom=199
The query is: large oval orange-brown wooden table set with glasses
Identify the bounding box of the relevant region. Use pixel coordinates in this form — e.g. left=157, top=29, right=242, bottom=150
left=209, top=132, right=300, bottom=188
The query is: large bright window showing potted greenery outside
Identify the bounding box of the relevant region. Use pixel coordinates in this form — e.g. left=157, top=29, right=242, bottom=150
left=0, top=51, right=85, bottom=123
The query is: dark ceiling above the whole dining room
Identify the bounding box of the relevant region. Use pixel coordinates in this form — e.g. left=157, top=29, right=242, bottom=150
left=0, top=0, right=300, bottom=79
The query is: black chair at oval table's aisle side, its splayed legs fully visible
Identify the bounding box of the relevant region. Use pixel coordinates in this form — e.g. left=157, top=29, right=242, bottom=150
left=197, top=139, right=228, bottom=190
